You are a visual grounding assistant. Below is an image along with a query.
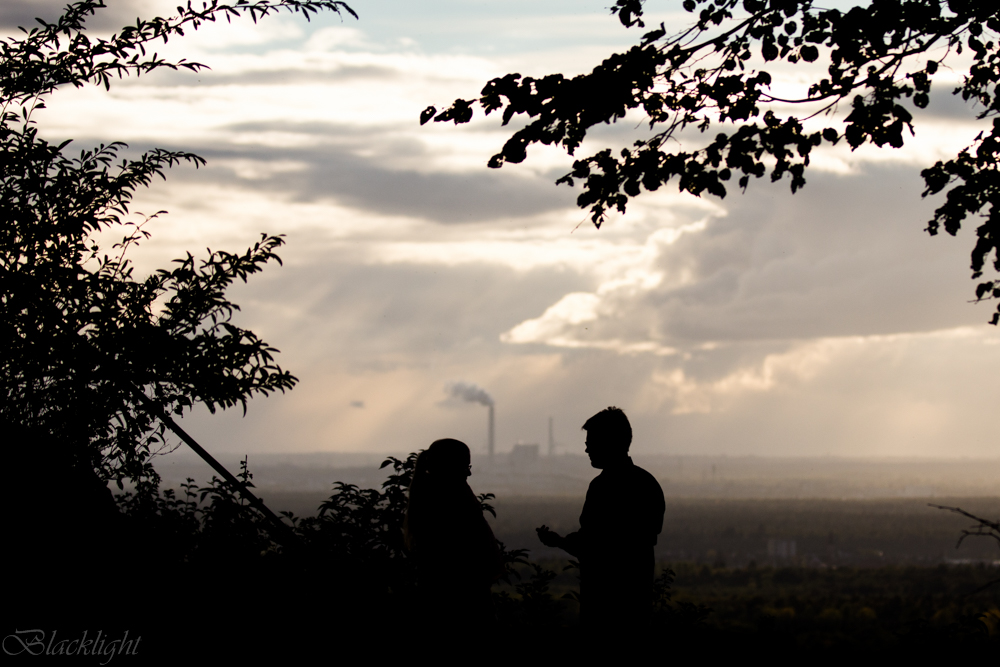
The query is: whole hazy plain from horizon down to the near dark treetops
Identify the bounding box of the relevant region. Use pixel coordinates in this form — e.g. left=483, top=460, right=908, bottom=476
left=150, top=447, right=1000, bottom=567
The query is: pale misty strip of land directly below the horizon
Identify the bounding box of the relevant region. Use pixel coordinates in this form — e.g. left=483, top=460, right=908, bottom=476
left=154, top=452, right=1000, bottom=499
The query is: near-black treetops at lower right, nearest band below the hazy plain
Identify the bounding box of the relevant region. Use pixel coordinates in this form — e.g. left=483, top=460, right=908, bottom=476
left=522, top=559, right=1000, bottom=645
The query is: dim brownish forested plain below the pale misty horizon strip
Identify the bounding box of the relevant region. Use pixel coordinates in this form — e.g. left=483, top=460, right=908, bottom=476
left=495, top=497, right=1000, bottom=576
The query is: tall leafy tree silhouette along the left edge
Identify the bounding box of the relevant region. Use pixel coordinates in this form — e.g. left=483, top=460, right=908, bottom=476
left=0, top=0, right=353, bottom=485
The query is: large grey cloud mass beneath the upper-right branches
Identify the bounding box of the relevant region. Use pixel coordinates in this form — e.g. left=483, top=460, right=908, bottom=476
left=643, top=166, right=989, bottom=344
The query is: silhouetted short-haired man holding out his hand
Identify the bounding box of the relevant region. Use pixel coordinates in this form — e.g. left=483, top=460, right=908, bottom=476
left=537, top=407, right=665, bottom=631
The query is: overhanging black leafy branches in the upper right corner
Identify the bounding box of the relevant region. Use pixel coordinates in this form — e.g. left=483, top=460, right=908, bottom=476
left=421, top=0, right=1000, bottom=324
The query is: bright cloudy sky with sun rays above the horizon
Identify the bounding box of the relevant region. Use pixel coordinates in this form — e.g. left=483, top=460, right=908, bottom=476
left=7, top=0, right=1000, bottom=458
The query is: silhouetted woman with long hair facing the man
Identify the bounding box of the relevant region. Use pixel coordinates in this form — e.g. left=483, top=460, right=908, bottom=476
left=403, top=438, right=503, bottom=627
